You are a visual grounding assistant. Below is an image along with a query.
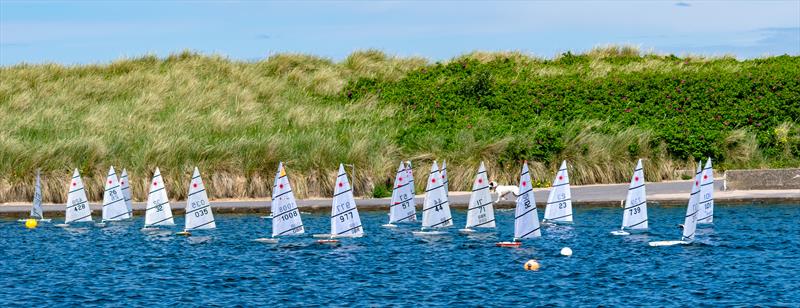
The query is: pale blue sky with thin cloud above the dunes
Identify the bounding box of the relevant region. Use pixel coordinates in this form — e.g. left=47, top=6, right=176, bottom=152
left=0, top=0, right=800, bottom=65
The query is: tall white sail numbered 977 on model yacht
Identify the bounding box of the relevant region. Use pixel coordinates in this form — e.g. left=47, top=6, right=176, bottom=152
left=331, top=164, right=364, bottom=237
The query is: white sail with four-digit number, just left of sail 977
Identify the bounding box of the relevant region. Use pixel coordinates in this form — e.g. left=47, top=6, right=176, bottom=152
left=271, top=162, right=305, bottom=237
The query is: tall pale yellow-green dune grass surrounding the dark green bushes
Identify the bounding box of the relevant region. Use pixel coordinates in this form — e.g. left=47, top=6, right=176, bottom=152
left=0, top=47, right=800, bottom=202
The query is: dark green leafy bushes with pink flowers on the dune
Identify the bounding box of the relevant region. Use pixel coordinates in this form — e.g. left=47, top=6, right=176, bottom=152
left=344, top=52, right=800, bottom=161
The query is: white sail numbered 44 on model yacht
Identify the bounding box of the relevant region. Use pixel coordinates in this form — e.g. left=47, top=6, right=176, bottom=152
left=422, top=161, right=453, bottom=228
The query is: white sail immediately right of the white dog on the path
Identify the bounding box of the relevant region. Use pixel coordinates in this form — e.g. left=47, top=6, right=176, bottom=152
left=514, top=162, right=542, bottom=239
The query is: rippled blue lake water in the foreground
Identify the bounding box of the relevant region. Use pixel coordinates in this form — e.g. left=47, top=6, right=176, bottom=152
left=0, top=205, right=800, bottom=307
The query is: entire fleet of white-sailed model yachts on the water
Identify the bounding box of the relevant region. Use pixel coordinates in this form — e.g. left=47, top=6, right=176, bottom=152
left=30, top=158, right=714, bottom=247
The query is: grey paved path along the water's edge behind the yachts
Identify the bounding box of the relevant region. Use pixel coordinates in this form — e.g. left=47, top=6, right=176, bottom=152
left=0, top=179, right=800, bottom=217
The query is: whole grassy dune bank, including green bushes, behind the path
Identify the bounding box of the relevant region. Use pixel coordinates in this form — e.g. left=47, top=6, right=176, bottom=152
left=0, top=47, right=800, bottom=202
